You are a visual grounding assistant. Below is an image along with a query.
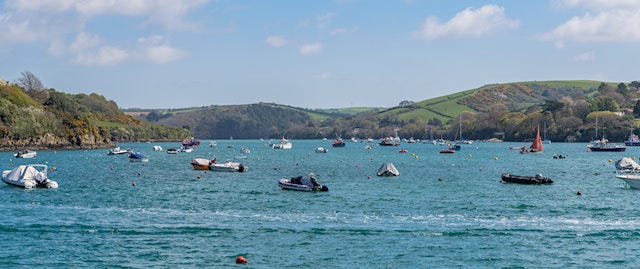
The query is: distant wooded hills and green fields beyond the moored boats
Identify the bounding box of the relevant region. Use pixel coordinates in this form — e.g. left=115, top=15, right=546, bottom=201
left=138, top=80, right=640, bottom=141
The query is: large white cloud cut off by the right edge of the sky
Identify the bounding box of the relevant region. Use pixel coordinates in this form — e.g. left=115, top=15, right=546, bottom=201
left=541, top=9, right=640, bottom=43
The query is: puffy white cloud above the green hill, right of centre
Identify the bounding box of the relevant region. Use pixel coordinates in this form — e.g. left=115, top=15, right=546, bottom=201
left=414, top=5, right=520, bottom=39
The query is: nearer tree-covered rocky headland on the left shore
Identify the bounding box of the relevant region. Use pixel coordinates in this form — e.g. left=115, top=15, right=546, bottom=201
left=0, top=72, right=191, bottom=150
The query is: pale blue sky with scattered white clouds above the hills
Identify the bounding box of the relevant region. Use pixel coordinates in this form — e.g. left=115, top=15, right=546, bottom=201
left=0, top=0, right=640, bottom=108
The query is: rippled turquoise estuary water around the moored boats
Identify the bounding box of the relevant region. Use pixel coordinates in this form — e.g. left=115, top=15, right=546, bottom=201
left=0, top=140, right=640, bottom=268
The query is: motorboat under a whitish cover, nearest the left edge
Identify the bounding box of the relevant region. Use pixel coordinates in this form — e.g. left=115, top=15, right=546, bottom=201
left=2, top=164, right=58, bottom=189
